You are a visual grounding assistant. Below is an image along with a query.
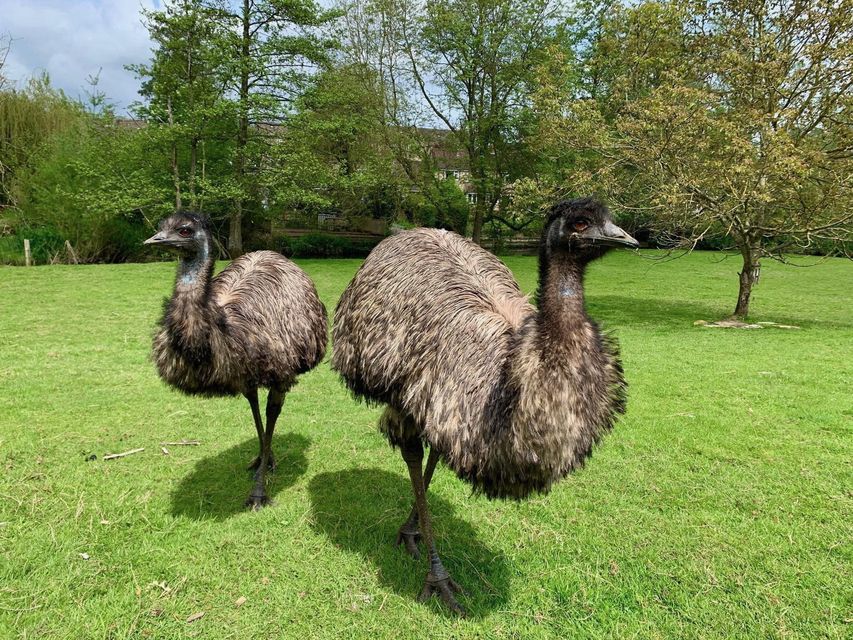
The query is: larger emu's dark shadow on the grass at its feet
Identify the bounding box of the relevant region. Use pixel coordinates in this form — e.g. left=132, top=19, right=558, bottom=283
left=308, top=468, right=509, bottom=618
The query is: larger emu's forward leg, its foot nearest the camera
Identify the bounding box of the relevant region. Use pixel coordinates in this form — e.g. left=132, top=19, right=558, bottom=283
left=400, top=438, right=465, bottom=616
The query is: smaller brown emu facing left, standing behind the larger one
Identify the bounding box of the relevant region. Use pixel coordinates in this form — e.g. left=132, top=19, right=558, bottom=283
left=145, top=212, right=327, bottom=509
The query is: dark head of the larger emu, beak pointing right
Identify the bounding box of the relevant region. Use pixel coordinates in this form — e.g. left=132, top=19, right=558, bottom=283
left=542, top=198, right=640, bottom=263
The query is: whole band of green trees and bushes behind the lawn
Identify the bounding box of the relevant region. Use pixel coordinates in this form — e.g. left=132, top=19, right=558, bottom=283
left=0, top=0, right=853, bottom=316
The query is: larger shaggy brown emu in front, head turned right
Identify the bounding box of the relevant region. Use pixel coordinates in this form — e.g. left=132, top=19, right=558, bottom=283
left=332, top=198, right=638, bottom=614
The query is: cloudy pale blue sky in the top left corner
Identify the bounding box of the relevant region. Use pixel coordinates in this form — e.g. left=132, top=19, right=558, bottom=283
left=0, top=0, right=160, bottom=115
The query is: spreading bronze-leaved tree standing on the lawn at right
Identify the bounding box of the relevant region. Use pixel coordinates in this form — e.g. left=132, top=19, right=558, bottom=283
left=541, top=0, right=853, bottom=318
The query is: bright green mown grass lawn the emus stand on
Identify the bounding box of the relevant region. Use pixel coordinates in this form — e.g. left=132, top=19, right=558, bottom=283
left=0, top=253, right=853, bottom=639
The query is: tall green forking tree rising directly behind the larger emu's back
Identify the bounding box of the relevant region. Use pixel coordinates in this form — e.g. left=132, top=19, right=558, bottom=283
left=410, top=0, right=556, bottom=242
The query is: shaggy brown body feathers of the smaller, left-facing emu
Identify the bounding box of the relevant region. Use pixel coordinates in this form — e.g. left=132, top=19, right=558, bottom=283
left=154, top=251, right=326, bottom=395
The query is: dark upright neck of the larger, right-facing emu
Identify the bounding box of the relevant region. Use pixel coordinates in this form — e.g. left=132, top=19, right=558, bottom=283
left=539, top=252, right=588, bottom=345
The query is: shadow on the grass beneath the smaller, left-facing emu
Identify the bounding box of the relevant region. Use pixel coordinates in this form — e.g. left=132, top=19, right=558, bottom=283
left=172, top=433, right=311, bottom=520
